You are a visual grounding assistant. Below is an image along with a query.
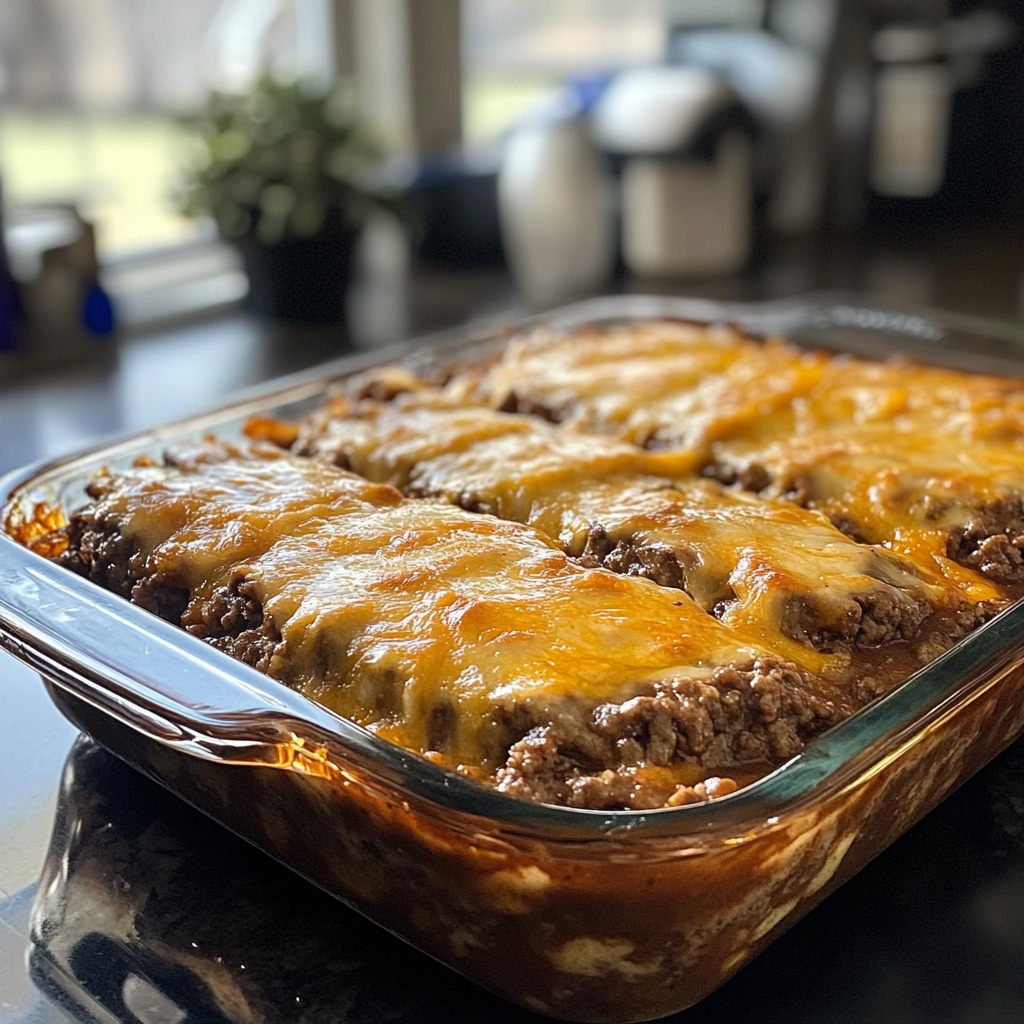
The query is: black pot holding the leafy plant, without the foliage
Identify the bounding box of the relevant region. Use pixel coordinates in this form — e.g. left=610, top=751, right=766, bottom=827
left=236, top=227, right=359, bottom=324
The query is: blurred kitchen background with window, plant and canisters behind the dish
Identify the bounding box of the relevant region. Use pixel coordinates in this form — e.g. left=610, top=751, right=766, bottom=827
left=0, top=0, right=1024, bottom=456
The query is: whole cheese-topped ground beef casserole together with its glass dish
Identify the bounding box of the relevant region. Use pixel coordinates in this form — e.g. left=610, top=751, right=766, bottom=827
left=0, top=299, right=1024, bottom=1021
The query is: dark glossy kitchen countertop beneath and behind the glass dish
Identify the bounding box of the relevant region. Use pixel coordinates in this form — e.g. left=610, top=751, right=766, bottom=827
left=0, top=228, right=1024, bottom=1024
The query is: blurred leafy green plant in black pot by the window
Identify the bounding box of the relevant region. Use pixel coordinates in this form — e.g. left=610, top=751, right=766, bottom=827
left=177, top=72, right=389, bottom=323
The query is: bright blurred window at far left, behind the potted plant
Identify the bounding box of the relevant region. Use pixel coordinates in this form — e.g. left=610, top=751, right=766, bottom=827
left=0, top=0, right=331, bottom=263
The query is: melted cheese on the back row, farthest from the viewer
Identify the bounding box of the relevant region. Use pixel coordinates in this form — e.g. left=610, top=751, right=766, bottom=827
left=460, top=323, right=1024, bottom=601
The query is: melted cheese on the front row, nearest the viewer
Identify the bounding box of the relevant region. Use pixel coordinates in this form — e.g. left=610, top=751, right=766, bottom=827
left=91, top=446, right=794, bottom=764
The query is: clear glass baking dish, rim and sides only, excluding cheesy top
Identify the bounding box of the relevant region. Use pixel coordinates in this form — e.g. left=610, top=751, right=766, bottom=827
left=0, top=296, right=1024, bottom=1022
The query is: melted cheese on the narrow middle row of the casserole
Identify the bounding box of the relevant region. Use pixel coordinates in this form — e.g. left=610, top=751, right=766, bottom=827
left=301, top=394, right=954, bottom=672
